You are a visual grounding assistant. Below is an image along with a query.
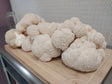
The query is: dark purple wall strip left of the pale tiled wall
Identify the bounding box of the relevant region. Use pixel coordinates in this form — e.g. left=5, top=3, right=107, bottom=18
left=0, top=0, right=11, bottom=47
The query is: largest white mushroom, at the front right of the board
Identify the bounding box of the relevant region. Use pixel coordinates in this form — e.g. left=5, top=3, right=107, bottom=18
left=62, top=39, right=105, bottom=72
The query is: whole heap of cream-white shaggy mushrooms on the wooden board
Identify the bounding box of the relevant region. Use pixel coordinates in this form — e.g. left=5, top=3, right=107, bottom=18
left=5, top=13, right=106, bottom=72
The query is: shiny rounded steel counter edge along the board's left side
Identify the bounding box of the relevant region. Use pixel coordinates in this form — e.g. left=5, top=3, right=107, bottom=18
left=0, top=49, right=44, bottom=84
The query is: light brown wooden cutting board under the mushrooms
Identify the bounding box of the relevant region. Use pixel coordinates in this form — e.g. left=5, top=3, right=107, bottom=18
left=5, top=45, right=112, bottom=84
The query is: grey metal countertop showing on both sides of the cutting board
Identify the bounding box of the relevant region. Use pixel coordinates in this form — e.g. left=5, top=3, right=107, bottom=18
left=0, top=46, right=112, bottom=84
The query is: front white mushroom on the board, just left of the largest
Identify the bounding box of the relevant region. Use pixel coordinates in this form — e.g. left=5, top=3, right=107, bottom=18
left=31, top=34, right=61, bottom=61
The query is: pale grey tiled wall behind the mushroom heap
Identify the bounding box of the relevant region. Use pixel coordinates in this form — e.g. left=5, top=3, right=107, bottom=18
left=10, top=0, right=112, bottom=45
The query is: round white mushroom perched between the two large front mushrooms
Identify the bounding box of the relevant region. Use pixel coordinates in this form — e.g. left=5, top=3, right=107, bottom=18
left=51, top=29, right=75, bottom=51
